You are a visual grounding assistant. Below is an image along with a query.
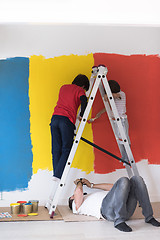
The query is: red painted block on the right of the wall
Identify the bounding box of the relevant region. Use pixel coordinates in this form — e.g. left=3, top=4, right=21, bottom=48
left=92, top=53, right=160, bottom=173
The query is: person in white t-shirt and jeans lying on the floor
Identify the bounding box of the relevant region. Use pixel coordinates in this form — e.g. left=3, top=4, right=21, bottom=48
left=69, top=176, right=160, bottom=232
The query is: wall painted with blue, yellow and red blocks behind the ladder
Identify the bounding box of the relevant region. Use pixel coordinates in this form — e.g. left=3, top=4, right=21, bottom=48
left=0, top=24, right=160, bottom=206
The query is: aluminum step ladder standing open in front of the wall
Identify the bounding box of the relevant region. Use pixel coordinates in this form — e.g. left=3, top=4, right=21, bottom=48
left=49, top=65, right=139, bottom=218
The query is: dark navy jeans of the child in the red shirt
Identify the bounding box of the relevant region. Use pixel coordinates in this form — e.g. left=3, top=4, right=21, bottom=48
left=50, top=115, right=75, bottom=178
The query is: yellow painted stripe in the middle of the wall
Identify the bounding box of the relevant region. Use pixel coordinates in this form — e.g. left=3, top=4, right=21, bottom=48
left=29, top=54, right=94, bottom=173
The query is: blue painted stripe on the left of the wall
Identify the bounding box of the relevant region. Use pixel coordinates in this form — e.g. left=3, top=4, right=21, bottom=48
left=0, top=57, right=33, bottom=191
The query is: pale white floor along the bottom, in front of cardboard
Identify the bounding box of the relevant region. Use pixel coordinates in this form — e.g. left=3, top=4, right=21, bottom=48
left=0, top=219, right=160, bottom=240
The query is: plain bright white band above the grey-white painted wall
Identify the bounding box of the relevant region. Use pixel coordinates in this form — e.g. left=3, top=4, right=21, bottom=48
left=0, top=0, right=160, bottom=26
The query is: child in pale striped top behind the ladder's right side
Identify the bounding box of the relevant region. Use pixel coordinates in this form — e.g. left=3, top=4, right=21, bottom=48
left=88, top=80, right=131, bottom=166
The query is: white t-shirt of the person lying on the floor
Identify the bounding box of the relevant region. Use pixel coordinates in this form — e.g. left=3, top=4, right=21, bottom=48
left=72, top=191, right=108, bottom=219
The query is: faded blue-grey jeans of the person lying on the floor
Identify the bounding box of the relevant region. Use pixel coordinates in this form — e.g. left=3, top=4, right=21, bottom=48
left=101, top=176, right=153, bottom=226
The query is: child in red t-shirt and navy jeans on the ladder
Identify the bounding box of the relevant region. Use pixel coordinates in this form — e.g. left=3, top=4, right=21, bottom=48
left=50, top=74, right=89, bottom=180
